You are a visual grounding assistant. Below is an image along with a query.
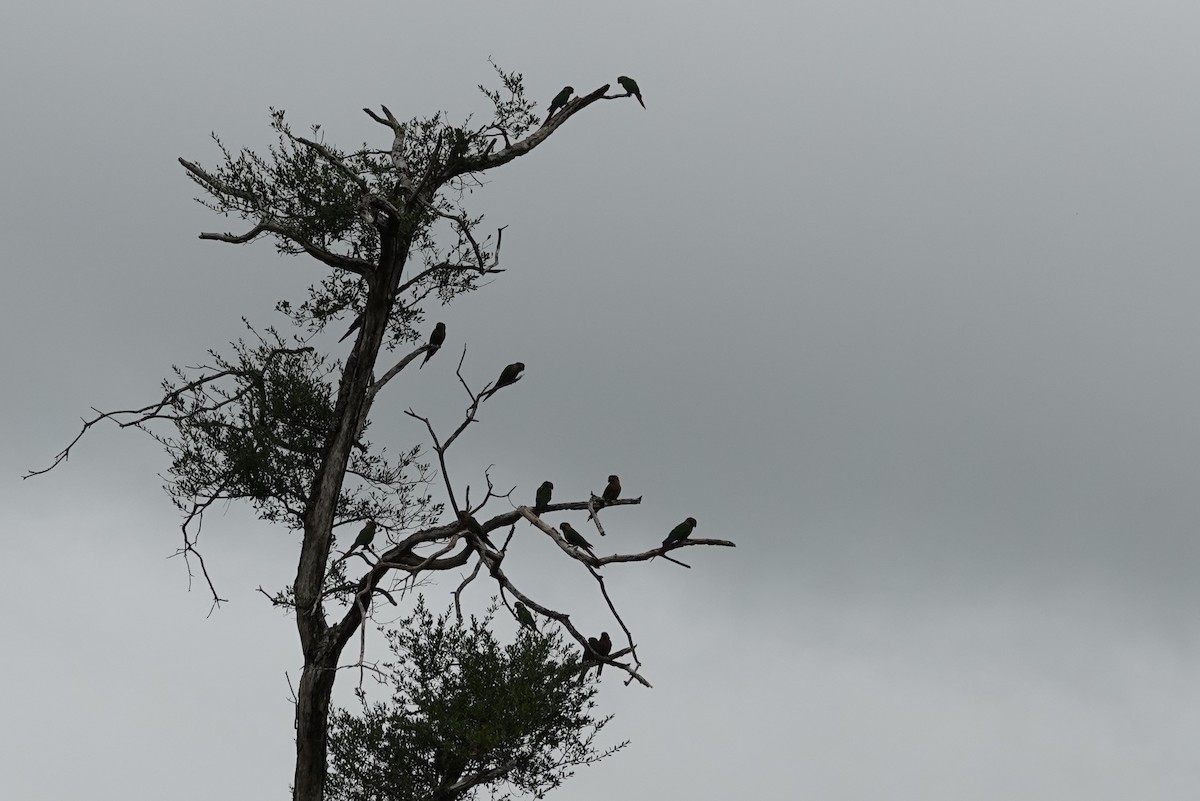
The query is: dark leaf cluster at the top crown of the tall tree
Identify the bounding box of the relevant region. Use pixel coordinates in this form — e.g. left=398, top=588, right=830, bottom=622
left=190, top=65, right=538, bottom=348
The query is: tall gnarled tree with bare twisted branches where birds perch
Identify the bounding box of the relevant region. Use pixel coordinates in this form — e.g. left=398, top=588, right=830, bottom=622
left=29, top=70, right=733, bottom=801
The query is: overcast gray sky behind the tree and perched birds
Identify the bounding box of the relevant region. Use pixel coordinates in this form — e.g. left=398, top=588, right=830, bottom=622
left=7, top=0, right=1200, bottom=801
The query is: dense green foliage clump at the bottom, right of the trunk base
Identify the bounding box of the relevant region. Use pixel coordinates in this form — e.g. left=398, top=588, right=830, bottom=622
left=326, top=600, right=625, bottom=801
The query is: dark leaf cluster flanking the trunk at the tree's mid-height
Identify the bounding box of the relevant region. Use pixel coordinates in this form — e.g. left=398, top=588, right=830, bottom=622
left=157, top=329, right=438, bottom=528
